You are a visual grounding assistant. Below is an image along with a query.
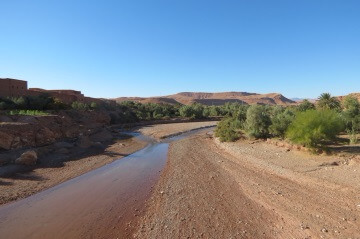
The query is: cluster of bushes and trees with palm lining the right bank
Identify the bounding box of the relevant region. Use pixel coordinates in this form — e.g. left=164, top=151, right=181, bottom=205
left=216, top=93, right=360, bottom=148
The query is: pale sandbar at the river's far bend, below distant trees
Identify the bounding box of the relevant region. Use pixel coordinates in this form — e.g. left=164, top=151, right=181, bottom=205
left=137, top=121, right=217, bottom=139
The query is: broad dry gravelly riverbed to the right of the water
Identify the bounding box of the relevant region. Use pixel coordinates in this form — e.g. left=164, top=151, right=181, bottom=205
left=135, top=134, right=360, bottom=239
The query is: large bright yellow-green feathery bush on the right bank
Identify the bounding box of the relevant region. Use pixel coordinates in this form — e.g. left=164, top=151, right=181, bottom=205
left=286, top=110, right=344, bottom=148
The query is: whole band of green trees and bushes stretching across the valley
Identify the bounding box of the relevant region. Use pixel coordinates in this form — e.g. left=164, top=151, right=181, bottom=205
left=0, top=93, right=360, bottom=148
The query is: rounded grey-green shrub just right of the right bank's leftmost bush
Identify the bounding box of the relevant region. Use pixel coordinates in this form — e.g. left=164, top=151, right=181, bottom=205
left=245, top=105, right=271, bottom=138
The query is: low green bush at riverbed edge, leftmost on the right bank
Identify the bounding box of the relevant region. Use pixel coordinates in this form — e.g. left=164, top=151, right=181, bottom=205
left=215, top=118, right=240, bottom=142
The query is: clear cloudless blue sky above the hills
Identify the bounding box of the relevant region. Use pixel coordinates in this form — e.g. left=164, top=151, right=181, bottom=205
left=0, top=0, right=360, bottom=98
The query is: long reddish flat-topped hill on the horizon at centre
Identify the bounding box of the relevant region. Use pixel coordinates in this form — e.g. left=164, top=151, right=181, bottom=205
left=115, top=92, right=296, bottom=105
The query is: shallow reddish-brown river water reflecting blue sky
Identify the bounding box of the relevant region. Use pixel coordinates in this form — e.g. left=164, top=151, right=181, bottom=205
left=0, top=131, right=212, bottom=239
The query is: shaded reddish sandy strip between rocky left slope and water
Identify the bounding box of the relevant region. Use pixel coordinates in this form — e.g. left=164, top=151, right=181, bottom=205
left=0, top=139, right=146, bottom=204
